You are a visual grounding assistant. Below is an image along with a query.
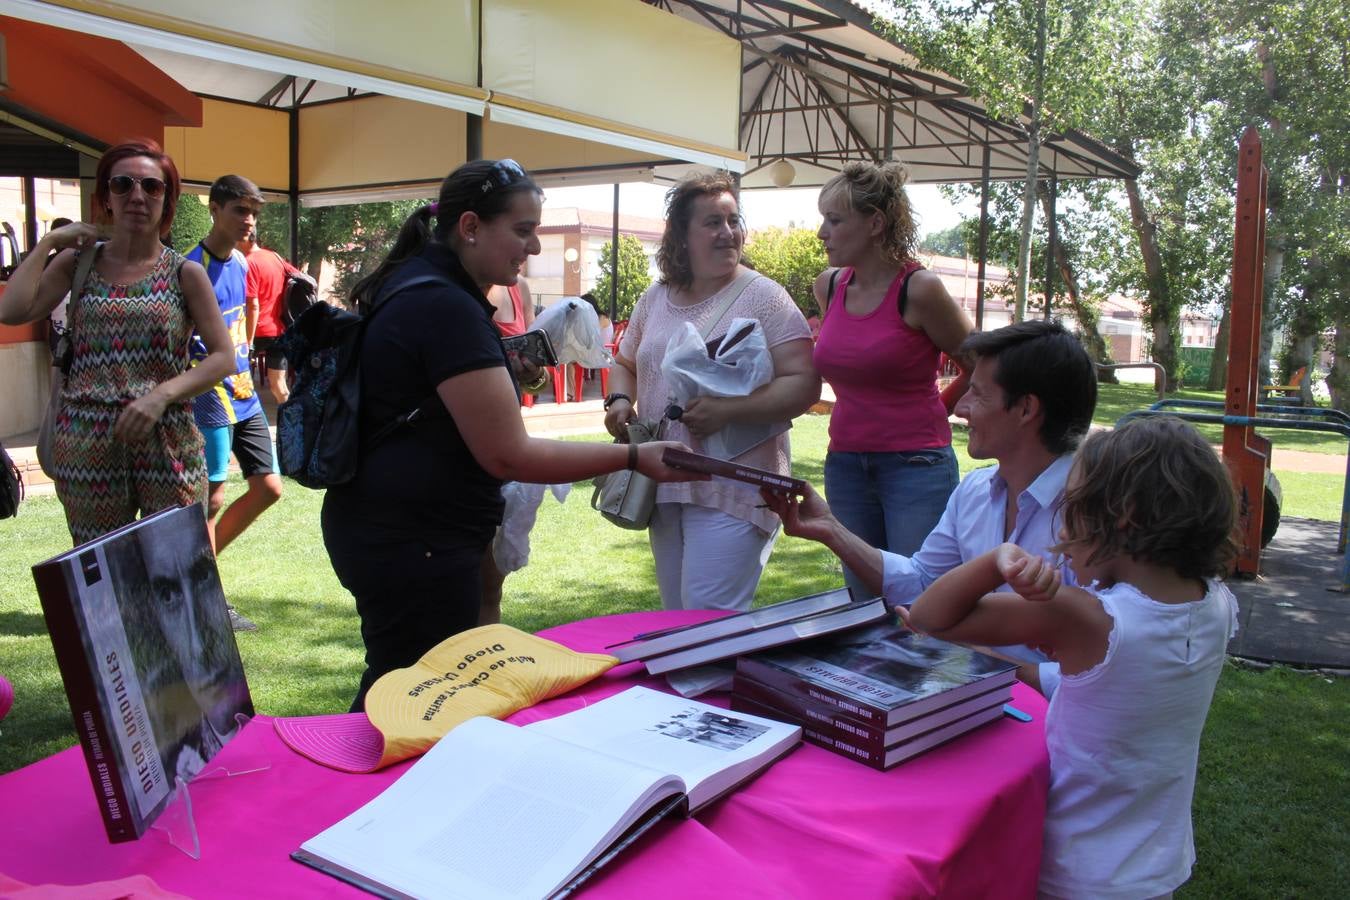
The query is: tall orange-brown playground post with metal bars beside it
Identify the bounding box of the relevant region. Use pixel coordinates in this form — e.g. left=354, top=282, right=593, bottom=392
left=1121, top=128, right=1350, bottom=592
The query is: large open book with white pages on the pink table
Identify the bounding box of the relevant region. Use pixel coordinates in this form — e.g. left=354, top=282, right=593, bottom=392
left=293, top=687, right=802, bottom=900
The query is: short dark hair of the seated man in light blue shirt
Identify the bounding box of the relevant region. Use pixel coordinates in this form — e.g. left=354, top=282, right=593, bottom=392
left=957, top=320, right=1096, bottom=453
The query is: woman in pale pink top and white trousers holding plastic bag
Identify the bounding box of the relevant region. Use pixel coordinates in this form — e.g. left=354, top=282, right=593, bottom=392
left=605, top=173, right=821, bottom=610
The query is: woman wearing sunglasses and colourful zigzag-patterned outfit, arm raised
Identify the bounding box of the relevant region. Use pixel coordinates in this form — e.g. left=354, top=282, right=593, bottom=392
left=0, top=140, right=234, bottom=544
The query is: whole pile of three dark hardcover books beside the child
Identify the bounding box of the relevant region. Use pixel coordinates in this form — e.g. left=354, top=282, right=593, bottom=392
left=732, top=623, right=1017, bottom=769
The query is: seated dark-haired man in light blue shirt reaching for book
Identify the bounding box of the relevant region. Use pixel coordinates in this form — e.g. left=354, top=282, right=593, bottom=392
left=765, top=321, right=1096, bottom=696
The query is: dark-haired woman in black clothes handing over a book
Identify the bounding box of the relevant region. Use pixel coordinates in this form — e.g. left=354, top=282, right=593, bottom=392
left=315, top=159, right=694, bottom=711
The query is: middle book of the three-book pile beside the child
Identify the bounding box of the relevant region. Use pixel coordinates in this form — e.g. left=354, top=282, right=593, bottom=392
left=732, top=675, right=1013, bottom=753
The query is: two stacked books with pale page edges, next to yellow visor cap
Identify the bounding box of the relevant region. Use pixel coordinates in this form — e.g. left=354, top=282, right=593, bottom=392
left=606, top=587, right=891, bottom=675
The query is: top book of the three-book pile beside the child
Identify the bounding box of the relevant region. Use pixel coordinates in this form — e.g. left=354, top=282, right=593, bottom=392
left=736, top=623, right=1017, bottom=729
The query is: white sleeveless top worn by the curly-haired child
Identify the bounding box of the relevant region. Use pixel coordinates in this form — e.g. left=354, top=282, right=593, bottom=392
left=1041, top=580, right=1238, bottom=897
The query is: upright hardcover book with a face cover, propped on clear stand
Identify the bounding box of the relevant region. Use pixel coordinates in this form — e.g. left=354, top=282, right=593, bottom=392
left=32, top=506, right=254, bottom=842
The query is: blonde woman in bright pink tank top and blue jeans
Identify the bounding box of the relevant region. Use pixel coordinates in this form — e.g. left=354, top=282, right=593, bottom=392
left=814, top=162, right=971, bottom=596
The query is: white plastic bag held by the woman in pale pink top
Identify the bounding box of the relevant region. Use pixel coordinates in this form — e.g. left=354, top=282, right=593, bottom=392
left=662, top=318, right=791, bottom=459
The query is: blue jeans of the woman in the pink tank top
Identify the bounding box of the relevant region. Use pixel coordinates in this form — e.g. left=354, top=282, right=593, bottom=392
left=825, top=444, right=961, bottom=598
